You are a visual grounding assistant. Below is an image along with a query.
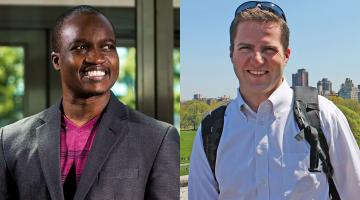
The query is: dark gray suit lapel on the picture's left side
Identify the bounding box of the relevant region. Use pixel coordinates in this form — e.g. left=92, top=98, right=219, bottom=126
left=36, top=103, right=64, bottom=200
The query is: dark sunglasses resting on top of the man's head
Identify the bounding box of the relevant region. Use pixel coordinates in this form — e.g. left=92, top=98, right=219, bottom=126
left=235, top=1, right=286, bottom=22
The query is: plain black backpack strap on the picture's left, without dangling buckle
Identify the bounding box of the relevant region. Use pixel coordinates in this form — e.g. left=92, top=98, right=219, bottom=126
left=201, top=104, right=227, bottom=192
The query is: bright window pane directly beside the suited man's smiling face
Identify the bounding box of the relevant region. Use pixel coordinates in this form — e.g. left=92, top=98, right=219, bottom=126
left=111, top=47, right=136, bottom=109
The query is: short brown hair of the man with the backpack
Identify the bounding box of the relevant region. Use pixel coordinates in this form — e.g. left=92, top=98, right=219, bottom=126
left=230, top=7, right=290, bottom=57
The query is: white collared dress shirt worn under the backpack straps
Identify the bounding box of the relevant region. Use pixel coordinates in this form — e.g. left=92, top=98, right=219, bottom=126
left=189, top=80, right=360, bottom=200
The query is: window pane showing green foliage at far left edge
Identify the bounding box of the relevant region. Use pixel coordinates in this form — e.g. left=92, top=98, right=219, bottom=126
left=0, top=46, right=24, bottom=127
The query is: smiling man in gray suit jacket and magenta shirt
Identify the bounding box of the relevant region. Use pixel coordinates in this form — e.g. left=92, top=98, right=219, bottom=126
left=0, top=6, right=179, bottom=200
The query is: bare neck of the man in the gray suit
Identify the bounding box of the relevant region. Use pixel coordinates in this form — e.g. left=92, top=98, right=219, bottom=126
left=62, top=92, right=111, bottom=126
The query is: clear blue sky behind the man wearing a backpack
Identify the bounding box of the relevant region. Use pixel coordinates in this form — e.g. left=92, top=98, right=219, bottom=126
left=180, top=0, right=360, bottom=100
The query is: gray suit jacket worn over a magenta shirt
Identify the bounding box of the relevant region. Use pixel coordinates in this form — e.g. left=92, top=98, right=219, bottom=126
left=0, top=95, right=180, bottom=200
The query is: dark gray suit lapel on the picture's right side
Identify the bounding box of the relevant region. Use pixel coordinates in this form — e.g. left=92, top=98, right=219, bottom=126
left=74, top=95, right=128, bottom=200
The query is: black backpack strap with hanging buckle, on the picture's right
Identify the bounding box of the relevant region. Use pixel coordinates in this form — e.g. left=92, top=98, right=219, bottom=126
left=293, top=86, right=340, bottom=200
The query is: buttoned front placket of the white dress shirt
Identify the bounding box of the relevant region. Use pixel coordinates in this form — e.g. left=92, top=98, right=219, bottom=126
left=255, top=104, right=270, bottom=200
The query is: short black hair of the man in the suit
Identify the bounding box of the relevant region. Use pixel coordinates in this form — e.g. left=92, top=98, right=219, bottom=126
left=51, top=5, right=115, bottom=52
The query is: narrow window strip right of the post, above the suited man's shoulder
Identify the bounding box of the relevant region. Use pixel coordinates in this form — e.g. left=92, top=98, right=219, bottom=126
left=173, top=48, right=180, bottom=130
